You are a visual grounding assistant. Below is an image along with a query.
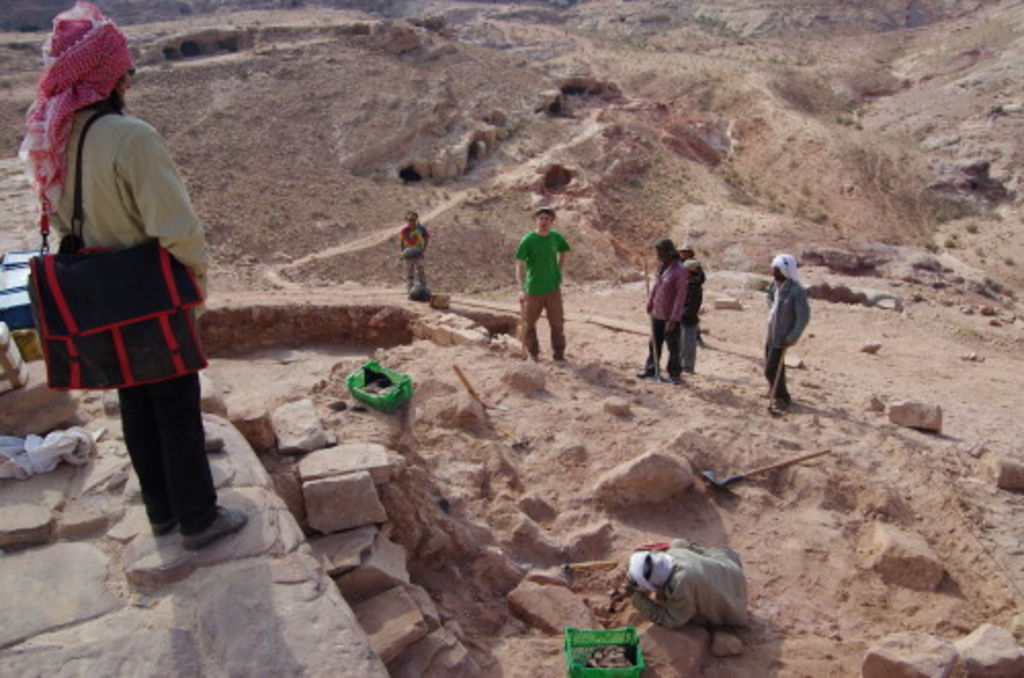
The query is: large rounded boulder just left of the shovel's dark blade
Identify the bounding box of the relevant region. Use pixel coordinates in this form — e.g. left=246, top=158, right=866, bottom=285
left=594, top=450, right=693, bottom=506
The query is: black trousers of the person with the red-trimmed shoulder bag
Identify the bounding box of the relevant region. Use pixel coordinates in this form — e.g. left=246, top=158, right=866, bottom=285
left=118, top=374, right=217, bottom=535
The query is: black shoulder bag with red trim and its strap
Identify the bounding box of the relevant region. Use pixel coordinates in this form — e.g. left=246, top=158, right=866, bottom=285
left=29, top=111, right=207, bottom=389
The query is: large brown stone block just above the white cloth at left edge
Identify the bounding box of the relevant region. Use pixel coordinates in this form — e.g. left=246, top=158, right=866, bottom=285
left=0, top=361, right=79, bottom=437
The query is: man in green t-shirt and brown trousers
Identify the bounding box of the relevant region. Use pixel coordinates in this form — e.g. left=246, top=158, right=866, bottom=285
left=515, top=207, right=569, bottom=361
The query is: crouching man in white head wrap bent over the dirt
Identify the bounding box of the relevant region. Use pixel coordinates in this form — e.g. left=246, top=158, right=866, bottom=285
left=627, top=539, right=746, bottom=629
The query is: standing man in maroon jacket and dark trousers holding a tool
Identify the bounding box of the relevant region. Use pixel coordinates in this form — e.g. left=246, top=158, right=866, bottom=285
left=637, top=238, right=686, bottom=384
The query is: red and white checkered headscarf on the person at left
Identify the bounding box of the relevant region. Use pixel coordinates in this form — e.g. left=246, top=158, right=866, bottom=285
left=18, top=2, right=132, bottom=231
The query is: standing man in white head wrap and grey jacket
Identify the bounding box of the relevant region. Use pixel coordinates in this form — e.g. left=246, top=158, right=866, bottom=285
left=765, top=254, right=811, bottom=408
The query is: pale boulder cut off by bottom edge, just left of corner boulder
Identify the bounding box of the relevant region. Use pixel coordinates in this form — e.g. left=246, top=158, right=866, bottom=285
left=860, top=632, right=956, bottom=678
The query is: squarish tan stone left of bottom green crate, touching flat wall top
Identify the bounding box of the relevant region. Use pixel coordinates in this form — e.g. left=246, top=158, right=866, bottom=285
left=352, top=586, right=429, bottom=663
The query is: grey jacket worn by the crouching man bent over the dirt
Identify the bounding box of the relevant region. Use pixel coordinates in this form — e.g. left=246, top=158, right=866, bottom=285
left=630, top=539, right=746, bottom=628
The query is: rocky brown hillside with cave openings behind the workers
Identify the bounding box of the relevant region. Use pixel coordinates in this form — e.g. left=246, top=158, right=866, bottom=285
left=0, top=2, right=1024, bottom=301
